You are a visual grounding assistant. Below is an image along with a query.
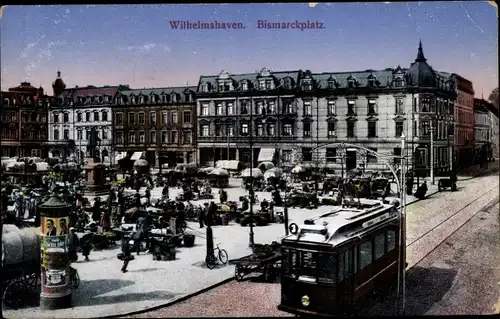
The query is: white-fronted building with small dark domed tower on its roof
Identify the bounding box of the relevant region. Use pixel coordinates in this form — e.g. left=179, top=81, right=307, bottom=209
left=49, top=72, right=128, bottom=162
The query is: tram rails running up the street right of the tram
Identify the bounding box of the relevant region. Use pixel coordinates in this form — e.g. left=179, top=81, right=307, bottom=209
left=406, top=184, right=499, bottom=270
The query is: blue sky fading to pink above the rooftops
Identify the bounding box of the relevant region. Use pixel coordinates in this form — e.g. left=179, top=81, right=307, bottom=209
left=0, top=1, right=498, bottom=98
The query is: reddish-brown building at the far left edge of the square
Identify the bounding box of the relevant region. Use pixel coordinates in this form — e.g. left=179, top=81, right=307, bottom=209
left=0, top=82, right=52, bottom=157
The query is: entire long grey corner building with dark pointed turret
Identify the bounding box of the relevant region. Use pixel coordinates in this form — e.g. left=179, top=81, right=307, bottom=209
left=197, top=44, right=456, bottom=175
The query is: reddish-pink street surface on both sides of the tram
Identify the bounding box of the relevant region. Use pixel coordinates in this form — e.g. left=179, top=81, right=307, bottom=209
left=130, top=173, right=500, bottom=318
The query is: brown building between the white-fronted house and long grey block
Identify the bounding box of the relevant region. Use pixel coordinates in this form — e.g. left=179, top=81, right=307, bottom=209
left=113, top=87, right=196, bottom=166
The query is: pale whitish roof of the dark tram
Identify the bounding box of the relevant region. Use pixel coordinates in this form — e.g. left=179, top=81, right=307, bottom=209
left=284, top=199, right=400, bottom=247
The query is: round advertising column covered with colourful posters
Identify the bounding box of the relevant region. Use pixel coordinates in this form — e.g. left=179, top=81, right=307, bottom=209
left=40, top=195, right=71, bottom=309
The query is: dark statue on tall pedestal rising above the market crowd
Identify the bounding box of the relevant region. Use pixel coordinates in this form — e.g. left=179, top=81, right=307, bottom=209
left=84, top=128, right=109, bottom=196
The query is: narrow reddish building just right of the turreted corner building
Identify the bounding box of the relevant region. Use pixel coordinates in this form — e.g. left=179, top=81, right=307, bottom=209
left=451, top=73, right=475, bottom=168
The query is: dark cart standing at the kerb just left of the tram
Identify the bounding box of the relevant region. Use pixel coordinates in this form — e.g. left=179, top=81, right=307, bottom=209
left=229, top=242, right=281, bottom=282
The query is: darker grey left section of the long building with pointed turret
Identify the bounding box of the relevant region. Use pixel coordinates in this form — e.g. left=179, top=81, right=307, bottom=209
left=196, top=68, right=300, bottom=166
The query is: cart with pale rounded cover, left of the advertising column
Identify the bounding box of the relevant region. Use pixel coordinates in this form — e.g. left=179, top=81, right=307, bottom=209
left=1, top=225, right=41, bottom=309
